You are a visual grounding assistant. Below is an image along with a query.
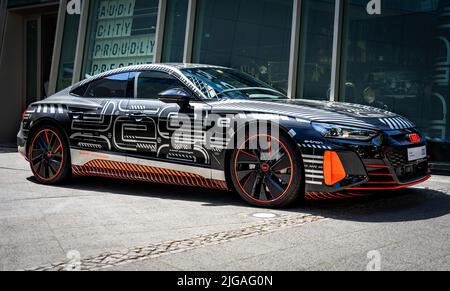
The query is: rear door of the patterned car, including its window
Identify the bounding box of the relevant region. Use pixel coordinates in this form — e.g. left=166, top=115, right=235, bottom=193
left=69, top=72, right=129, bottom=153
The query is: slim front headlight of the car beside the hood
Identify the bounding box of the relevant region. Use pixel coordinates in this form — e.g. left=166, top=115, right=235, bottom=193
left=311, top=122, right=378, bottom=141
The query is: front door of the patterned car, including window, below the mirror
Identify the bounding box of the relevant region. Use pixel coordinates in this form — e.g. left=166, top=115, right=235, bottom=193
left=128, top=71, right=210, bottom=166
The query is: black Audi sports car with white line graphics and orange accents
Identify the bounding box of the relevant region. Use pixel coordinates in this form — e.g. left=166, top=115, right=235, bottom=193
left=17, top=64, right=430, bottom=207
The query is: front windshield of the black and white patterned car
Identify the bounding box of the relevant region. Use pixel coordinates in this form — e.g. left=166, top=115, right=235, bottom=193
left=181, top=68, right=287, bottom=100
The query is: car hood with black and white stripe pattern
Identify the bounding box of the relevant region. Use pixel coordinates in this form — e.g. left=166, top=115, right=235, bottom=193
left=212, top=100, right=415, bottom=130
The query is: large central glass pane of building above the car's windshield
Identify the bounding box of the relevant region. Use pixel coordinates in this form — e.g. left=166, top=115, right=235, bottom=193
left=193, top=0, right=293, bottom=91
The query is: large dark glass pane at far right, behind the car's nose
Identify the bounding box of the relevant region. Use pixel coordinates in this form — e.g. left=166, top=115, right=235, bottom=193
left=340, top=0, right=450, bottom=162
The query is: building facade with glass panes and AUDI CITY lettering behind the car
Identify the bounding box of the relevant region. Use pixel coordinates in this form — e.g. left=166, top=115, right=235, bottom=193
left=0, top=0, right=450, bottom=168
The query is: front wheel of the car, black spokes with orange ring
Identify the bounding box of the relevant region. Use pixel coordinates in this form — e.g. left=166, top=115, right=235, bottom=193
left=229, top=132, right=305, bottom=208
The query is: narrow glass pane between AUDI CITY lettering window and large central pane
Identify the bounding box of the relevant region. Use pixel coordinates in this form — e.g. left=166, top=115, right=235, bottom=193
left=162, top=0, right=189, bottom=63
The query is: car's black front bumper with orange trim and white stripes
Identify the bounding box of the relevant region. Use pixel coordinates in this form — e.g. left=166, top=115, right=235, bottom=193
left=302, top=133, right=431, bottom=199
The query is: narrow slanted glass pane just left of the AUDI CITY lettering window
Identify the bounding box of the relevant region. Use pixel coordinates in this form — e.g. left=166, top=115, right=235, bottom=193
left=56, top=14, right=80, bottom=91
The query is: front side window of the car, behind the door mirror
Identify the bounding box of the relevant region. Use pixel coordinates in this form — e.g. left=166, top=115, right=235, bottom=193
left=135, top=71, right=184, bottom=99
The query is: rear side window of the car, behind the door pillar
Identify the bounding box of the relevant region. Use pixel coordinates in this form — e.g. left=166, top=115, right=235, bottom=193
left=84, top=73, right=130, bottom=98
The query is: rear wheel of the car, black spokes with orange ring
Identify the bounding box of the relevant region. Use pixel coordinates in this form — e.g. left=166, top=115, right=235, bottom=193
left=28, top=125, right=71, bottom=185
